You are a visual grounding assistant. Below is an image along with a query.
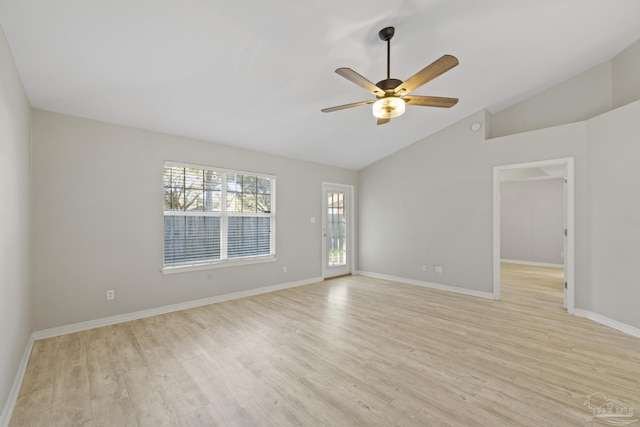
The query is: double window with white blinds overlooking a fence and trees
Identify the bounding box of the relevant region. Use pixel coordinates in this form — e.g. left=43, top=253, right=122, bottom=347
left=164, top=162, right=276, bottom=268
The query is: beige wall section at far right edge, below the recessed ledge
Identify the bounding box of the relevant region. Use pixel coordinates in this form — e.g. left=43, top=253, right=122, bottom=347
left=587, top=101, right=640, bottom=327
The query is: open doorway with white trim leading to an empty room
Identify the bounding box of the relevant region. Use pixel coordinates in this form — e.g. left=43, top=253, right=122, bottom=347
left=493, top=158, right=575, bottom=313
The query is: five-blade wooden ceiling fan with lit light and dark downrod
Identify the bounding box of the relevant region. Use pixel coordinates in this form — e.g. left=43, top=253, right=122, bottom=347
left=320, top=27, right=458, bottom=125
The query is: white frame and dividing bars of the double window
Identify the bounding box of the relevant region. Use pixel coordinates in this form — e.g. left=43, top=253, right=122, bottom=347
left=162, top=160, right=277, bottom=274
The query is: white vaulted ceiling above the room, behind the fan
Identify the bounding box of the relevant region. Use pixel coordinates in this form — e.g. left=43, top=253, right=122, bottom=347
left=0, top=0, right=640, bottom=170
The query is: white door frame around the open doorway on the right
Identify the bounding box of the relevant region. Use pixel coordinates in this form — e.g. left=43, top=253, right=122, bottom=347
left=493, top=157, right=575, bottom=314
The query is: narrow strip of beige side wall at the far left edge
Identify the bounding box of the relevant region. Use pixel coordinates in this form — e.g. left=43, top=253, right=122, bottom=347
left=0, top=28, right=31, bottom=425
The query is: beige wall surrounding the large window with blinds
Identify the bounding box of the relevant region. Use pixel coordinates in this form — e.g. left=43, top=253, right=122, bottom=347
left=33, top=110, right=356, bottom=330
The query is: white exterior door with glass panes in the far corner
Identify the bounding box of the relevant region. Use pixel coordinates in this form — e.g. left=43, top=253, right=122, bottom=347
left=322, top=184, right=353, bottom=278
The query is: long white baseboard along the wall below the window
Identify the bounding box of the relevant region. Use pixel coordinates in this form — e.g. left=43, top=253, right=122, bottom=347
left=33, top=277, right=323, bottom=340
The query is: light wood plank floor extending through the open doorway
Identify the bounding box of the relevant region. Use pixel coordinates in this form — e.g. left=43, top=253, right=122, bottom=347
left=10, top=264, right=640, bottom=427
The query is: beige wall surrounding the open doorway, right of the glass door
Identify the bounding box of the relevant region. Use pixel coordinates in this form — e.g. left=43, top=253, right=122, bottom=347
left=358, top=111, right=591, bottom=300
